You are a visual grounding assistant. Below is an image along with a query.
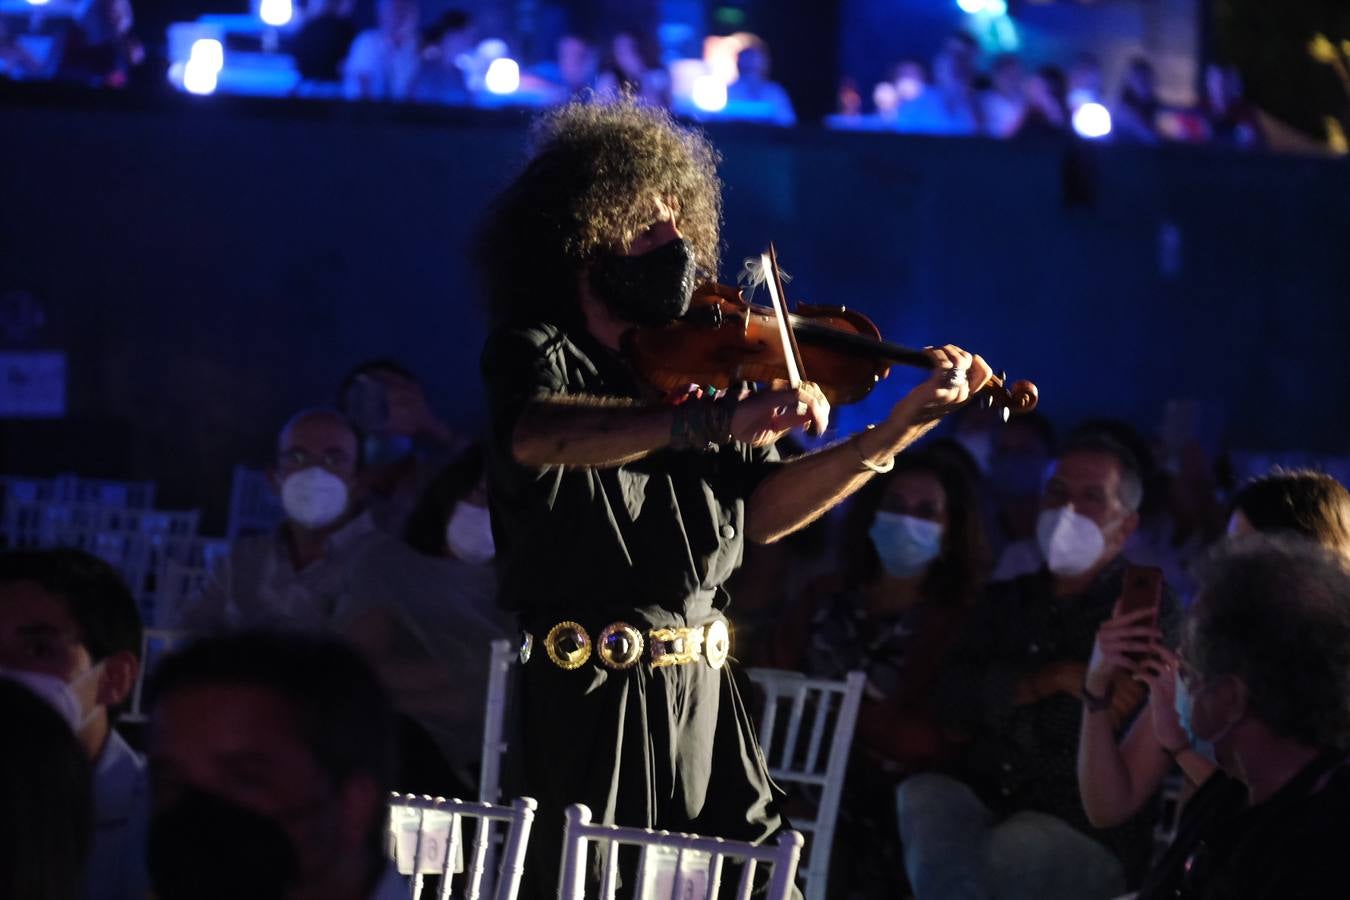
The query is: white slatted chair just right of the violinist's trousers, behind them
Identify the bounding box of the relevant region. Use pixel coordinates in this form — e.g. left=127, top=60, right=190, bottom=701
left=747, top=669, right=867, bottom=900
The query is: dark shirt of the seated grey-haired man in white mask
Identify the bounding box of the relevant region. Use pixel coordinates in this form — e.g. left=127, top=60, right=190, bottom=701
left=936, top=557, right=1176, bottom=881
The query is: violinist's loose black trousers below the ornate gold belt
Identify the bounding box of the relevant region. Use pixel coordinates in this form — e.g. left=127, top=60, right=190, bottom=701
left=513, top=650, right=786, bottom=900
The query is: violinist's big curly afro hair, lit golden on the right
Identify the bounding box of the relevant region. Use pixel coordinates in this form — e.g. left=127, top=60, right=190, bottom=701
left=475, top=99, right=722, bottom=324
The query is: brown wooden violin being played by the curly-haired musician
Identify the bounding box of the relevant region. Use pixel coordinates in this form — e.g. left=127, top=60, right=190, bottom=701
left=624, top=279, right=1040, bottom=421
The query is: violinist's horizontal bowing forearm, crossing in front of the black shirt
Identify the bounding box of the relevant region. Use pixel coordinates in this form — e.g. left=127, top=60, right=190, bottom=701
left=512, top=395, right=674, bottom=468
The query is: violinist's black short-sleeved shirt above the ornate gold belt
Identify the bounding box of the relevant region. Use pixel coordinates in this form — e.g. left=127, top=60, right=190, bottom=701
left=482, top=322, right=778, bottom=629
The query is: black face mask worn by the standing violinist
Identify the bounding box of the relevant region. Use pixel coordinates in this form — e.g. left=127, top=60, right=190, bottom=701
left=590, top=237, right=697, bottom=325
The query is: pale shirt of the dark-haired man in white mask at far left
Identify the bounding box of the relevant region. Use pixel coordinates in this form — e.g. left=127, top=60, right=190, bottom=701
left=84, top=731, right=149, bottom=900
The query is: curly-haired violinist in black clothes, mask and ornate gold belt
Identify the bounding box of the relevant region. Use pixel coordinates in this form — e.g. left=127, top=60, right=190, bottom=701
left=477, top=101, right=991, bottom=897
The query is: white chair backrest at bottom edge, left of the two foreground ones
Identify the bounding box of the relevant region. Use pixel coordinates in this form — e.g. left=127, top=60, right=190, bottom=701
left=389, top=793, right=536, bottom=900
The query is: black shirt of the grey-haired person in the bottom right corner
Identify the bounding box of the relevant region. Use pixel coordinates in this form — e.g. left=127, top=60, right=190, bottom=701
left=1139, top=752, right=1350, bottom=900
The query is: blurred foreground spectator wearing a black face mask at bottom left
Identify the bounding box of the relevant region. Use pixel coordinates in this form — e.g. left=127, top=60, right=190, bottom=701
left=149, top=634, right=409, bottom=900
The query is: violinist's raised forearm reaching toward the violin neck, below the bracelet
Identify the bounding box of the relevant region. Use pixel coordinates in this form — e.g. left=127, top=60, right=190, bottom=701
left=745, top=421, right=936, bottom=544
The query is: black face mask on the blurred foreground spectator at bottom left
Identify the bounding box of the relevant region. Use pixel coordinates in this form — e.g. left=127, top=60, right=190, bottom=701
left=147, top=791, right=300, bottom=900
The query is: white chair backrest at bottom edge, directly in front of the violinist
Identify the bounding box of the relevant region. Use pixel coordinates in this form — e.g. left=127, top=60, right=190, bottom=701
left=558, top=804, right=802, bottom=900
